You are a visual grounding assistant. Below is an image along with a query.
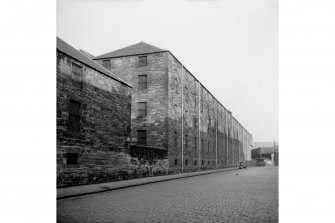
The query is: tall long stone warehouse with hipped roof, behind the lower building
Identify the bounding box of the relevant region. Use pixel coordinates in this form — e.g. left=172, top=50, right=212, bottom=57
left=94, top=42, right=253, bottom=171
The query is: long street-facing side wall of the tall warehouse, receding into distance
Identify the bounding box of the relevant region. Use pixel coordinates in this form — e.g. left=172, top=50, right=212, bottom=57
left=168, top=53, right=252, bottom=172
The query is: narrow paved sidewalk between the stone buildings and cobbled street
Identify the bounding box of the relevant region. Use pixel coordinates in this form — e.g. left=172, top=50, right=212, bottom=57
left=57, top=167, right=238, bottom=200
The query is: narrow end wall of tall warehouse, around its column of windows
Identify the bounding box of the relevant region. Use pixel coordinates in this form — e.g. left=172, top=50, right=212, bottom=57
left=96, top=52, right=168, bottom=149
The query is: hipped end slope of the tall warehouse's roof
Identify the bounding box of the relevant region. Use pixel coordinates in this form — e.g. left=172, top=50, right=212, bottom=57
left=94, top=42, right=167, bottom=59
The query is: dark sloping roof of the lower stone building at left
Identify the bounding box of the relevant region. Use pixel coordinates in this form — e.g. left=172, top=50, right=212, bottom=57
left=57, top=37, right=131, bottom=87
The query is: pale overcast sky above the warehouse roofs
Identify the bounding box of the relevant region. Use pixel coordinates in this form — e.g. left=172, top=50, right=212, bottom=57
left=57, top=0, right=278, bottom=141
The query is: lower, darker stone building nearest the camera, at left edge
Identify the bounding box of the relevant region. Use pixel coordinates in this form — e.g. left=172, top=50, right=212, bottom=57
left=57, top=38, right=131, bottom=185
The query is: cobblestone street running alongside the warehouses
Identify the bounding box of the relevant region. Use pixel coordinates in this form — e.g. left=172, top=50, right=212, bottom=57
left=57, top=166, right=278, bottom=223
